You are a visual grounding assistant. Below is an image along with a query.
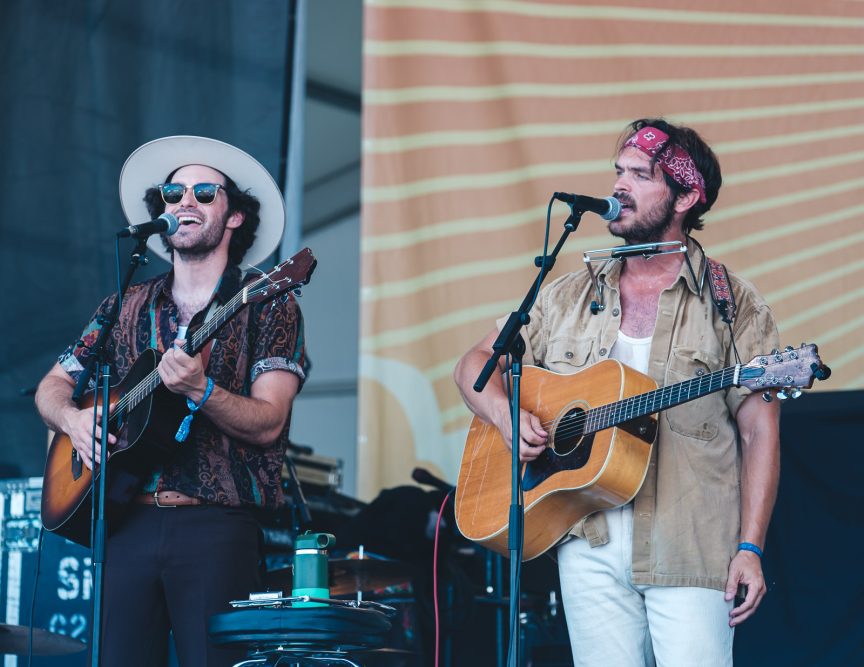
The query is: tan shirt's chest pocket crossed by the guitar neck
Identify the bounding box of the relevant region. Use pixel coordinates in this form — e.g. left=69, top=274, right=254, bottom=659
left=664, top=347, right=726, bottom=440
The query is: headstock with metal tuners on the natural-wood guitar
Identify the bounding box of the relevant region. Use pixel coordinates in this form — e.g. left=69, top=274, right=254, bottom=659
left=738, top=343, right=831, bottom=400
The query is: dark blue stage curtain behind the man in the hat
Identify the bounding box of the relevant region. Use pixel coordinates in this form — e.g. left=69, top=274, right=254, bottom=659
left=0, top=0, right=290, bottom=477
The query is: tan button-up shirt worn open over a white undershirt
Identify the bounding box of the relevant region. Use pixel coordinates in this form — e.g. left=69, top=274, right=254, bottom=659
left=510, top=245, right=780, bottom=590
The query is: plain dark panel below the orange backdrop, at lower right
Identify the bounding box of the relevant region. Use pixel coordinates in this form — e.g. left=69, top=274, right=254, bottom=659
left=735, top=388, right=864, bottom=667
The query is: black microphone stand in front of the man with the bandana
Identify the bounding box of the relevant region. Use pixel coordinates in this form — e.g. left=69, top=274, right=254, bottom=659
left=474, top=206, right=585, bottom=667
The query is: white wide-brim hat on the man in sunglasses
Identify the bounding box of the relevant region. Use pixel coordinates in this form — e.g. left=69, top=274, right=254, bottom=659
left=120, top=135, right=285, bottom=265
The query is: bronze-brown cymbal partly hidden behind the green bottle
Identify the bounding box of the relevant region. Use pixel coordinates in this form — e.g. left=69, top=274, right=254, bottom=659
left=264, top=558, right=411, bottom=595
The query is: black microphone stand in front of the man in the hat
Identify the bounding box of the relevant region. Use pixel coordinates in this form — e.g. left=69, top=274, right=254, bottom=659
left=72, top=234, right=149, bottom=667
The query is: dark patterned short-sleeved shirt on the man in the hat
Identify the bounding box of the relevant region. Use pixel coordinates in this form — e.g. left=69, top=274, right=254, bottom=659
left=59, top=266, right=309, bottom=507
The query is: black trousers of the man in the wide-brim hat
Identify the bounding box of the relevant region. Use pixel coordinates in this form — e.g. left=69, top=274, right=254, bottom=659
left=101, top=505, right=261, bottom=667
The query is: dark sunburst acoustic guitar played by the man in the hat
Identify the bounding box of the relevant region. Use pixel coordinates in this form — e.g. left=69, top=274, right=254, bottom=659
left=42, top=248, right=317, bottom=546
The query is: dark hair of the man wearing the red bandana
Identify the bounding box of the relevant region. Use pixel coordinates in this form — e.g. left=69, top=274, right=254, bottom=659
left=617, top=118, right=723, bottom=234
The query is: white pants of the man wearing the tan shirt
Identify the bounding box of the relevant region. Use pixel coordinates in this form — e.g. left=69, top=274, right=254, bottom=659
left=558, top=505, right=733, bottom=667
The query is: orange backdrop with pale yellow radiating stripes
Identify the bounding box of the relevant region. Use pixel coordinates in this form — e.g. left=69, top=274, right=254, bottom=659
left=358, top=0, right=864, bottom=497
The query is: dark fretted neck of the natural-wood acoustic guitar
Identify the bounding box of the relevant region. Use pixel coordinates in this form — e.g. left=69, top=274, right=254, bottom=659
left=585, top=365, right=741, bottom=433
